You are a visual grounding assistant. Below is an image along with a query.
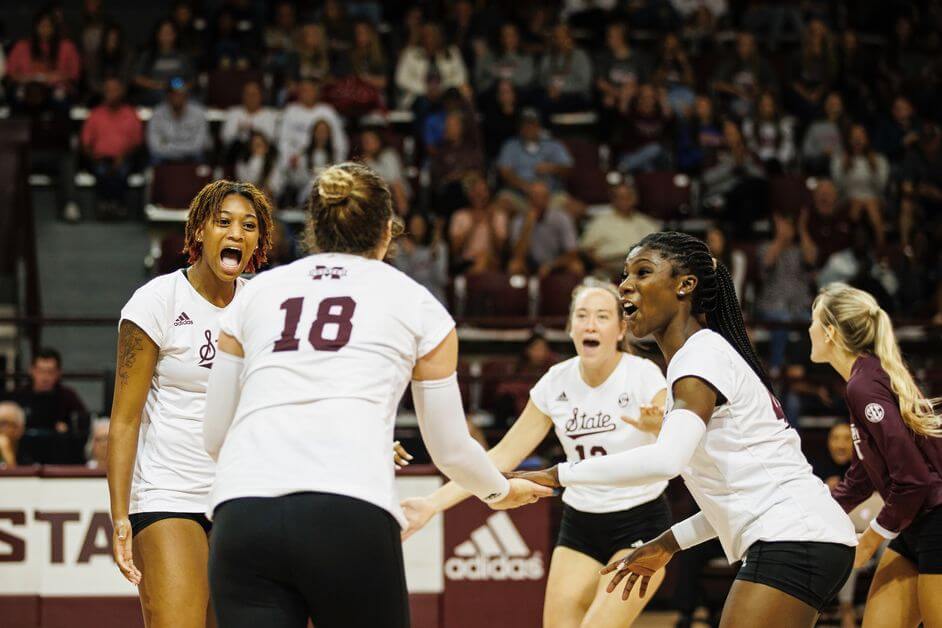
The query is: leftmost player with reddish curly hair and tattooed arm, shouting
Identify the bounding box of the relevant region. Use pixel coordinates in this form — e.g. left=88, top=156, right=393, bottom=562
left=108, top=180, right=272, bottom=628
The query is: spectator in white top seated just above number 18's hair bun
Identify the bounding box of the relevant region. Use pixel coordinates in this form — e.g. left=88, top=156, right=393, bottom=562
left=278, top=78, right=350, bottom=174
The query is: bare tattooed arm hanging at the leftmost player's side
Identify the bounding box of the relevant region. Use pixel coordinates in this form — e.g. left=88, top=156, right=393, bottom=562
left=108, top=320, right=159, bottom=584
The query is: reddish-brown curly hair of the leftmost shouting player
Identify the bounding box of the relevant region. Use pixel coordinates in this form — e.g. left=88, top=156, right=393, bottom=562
left=183, top=179, right=274, bottom=273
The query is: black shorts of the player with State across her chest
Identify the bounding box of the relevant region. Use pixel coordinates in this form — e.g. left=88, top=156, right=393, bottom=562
left=556, top=493, right=671, bottom=565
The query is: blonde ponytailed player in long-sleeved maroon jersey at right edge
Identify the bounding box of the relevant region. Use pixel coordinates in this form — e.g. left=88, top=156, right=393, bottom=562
left=809, top=283, right=942, bottom=626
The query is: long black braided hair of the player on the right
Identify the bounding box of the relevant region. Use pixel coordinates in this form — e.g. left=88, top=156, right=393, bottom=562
left=635, top=231, right=772, bottom=392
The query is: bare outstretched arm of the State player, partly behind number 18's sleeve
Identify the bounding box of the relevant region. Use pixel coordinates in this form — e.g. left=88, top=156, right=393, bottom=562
left=402, top=400, right=553, bottom=540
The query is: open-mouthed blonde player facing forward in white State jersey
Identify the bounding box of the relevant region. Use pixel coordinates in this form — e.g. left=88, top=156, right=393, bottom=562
left=402, top=279, right=671, bottom=628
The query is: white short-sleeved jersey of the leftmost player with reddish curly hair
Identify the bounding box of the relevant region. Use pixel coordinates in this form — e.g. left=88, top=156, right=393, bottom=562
left=121, top=270, right=245, bottom=513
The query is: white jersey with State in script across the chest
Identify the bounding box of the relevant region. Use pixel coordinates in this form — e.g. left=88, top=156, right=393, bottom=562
left=530, top=353, right=667, bottom=513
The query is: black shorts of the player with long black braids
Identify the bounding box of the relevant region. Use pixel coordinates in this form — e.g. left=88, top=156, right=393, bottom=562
left=736, top=541, right=855, bottom=611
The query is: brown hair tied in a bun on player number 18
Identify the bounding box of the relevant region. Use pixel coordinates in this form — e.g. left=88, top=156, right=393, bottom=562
left=308, top=162, right=402, bottom=255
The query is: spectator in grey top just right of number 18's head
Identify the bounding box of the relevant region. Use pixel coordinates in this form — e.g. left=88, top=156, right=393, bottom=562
left=392, top=212, right=448, bottom=303
